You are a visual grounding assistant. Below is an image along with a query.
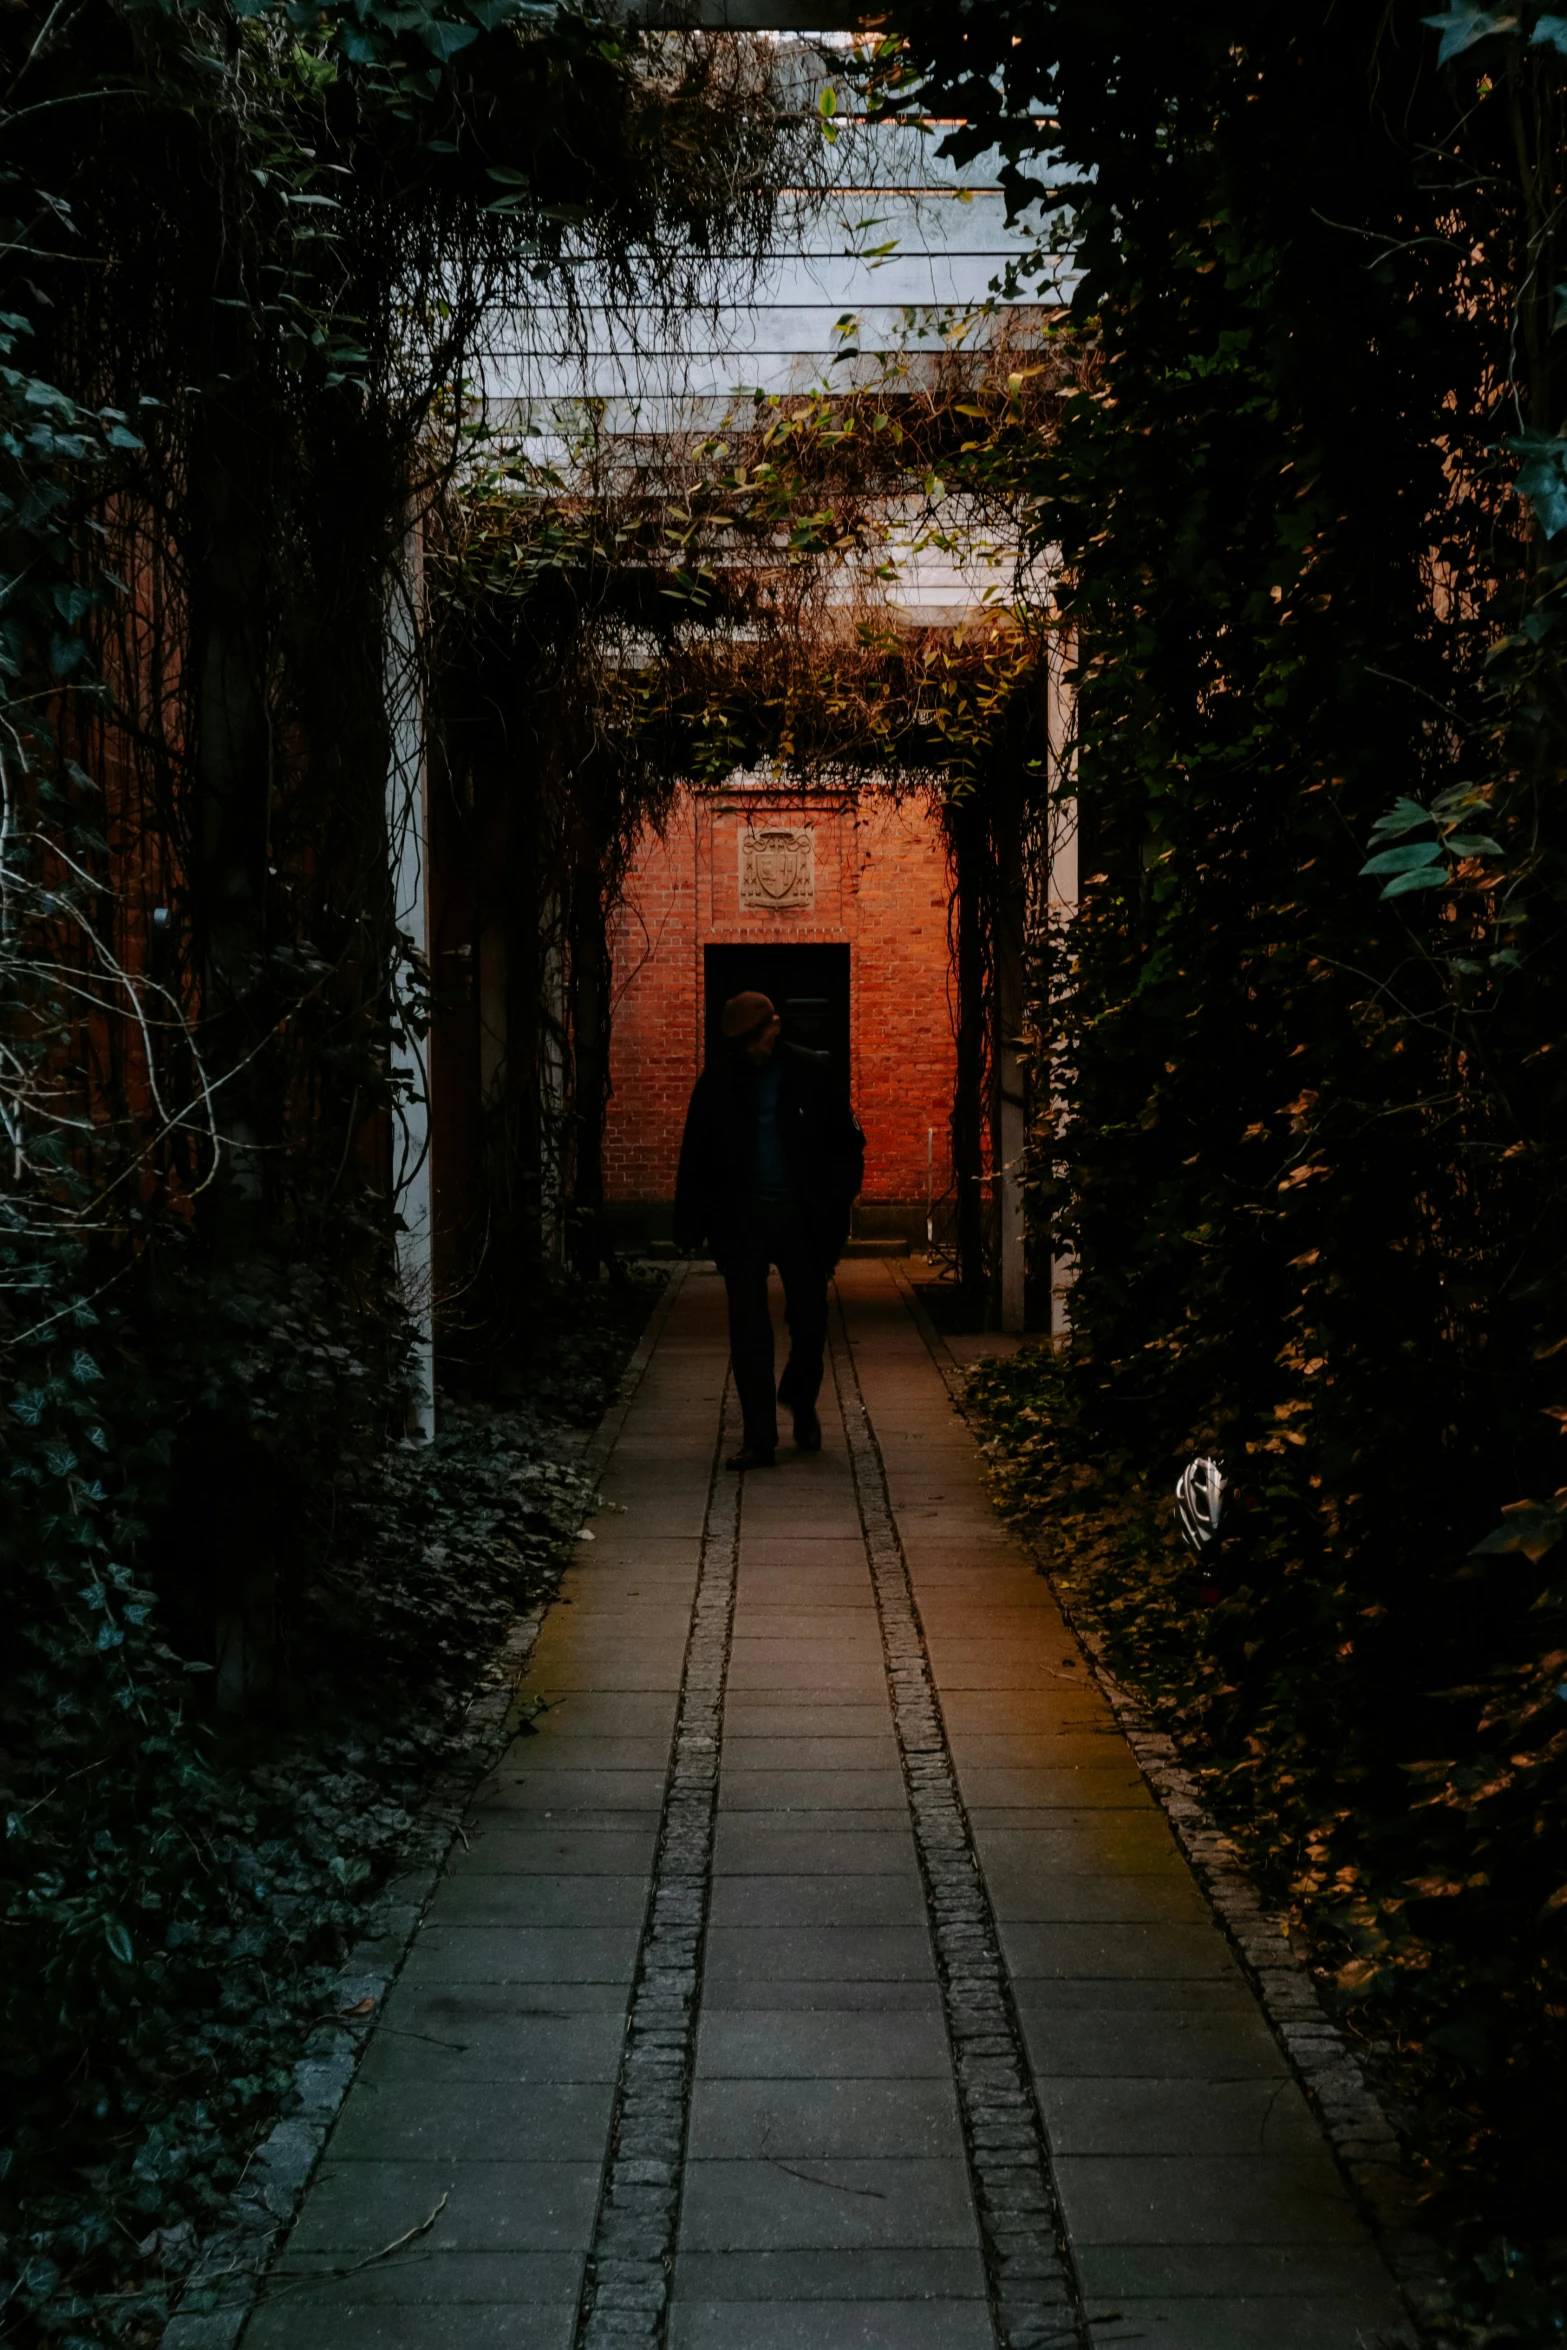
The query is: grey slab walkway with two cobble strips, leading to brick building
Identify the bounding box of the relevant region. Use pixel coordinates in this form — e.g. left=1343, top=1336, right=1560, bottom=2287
left=244, top=1264, right=1405, bottom=2350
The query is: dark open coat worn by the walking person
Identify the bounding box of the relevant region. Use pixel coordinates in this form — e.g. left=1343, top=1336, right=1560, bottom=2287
left=674, top=1043, right=865, bottom=1267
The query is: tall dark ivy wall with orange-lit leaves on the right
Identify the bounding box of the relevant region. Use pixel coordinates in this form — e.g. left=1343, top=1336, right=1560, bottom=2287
left=881, top=0, right=1567, bottom=2310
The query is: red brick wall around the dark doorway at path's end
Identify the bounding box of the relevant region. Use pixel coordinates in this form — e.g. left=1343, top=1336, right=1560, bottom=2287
left=606, top=785, right=954, bottom=1222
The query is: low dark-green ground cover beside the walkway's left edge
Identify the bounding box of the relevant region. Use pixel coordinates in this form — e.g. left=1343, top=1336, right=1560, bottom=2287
left=0, top=1283, right=655, bottom=2343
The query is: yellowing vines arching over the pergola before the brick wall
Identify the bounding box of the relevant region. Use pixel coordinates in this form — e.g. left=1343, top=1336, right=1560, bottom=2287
left=430, top=329, right=1076, bottom=1288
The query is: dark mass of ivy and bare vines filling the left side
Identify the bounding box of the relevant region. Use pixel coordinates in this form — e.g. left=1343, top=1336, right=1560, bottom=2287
left=0, top=0, right=803, bottom=2345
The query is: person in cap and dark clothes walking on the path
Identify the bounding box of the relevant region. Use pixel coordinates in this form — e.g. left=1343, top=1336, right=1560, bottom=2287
left=674, top=989, right=865, bottom=1469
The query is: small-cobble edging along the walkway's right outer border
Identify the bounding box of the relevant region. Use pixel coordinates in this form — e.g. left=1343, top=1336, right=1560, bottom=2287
left=888, top=1260, right=1445, bottom=2331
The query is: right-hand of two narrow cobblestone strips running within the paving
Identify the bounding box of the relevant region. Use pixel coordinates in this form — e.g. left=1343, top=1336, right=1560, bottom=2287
left=832, top=1302, right=1085, bottom=2350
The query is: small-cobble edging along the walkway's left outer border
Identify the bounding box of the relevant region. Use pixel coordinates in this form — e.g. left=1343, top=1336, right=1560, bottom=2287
left=160, top=1267, right=686, bottom=2350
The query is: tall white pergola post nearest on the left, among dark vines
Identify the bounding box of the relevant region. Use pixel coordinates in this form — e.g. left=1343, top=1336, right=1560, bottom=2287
left=375, top=524, right=435, bottom=1443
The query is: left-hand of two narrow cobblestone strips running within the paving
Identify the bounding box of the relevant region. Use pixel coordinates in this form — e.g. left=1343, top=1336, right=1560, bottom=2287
left=576, top=1410, right=742, bottom=2350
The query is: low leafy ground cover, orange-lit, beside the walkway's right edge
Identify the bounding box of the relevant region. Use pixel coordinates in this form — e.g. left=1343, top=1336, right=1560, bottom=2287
left=968, top=1351, right=1567, bottom=2343
